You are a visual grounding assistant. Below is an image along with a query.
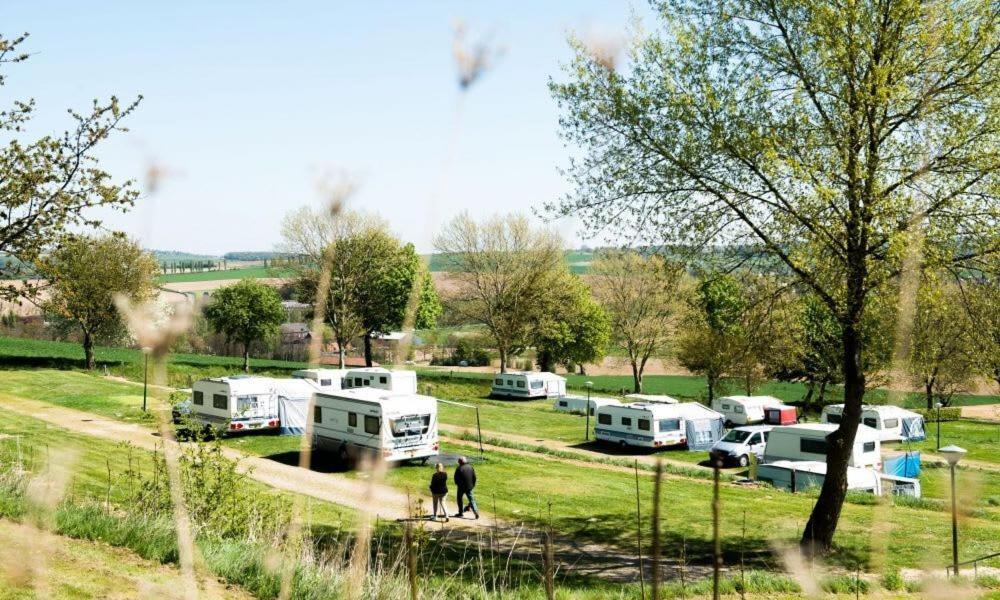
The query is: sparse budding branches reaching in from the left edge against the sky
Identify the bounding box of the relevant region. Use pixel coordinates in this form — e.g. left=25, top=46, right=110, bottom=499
left=0, top=34, right=141, bottom=299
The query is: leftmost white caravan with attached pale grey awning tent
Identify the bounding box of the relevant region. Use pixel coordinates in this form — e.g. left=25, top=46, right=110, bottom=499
left=190, top=375, right=319, bottom=433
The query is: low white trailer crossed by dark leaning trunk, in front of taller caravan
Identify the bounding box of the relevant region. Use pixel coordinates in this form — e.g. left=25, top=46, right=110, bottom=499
left=757, top=460, right=920, bottom=498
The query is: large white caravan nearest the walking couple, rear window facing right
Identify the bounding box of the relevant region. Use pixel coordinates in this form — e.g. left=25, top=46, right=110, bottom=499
left=313, top=387, right=438, bottom=462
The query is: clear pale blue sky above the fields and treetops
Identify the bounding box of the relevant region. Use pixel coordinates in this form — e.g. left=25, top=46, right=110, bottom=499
left=0, top=0, right=651, bottom=255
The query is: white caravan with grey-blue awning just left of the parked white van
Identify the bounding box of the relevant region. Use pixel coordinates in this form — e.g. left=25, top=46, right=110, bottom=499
left=594, top=402, right=722, bottom=450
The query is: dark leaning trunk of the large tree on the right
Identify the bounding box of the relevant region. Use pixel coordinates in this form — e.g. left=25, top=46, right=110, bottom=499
left=800, top=318, right=865, bottom=555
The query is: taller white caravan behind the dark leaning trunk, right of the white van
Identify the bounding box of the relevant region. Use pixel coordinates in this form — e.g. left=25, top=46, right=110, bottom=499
left=764, top=423, right=882, bottom=468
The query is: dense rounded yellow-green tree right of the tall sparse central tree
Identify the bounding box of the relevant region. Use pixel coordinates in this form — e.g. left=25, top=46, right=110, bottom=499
left=531, top=271, right=611, bottom=371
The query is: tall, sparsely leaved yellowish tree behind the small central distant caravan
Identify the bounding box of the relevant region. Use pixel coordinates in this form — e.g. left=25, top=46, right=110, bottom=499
left=435, top=214, right=566, bottom=372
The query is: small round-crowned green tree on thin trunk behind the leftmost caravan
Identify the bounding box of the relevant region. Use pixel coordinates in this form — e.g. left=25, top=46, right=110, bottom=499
left=204, top=279, right=285, bottom=373
